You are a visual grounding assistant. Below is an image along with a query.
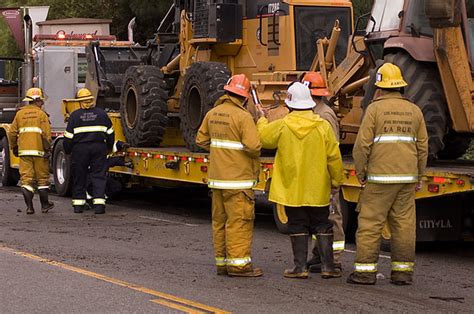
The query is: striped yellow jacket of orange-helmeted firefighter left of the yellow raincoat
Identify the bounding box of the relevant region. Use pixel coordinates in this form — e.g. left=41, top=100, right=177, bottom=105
left=196, top=95, right=261, bottom=189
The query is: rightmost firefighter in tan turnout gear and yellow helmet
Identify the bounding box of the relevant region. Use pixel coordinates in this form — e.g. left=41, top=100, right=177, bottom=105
left=347, top=63, right=428, bottom=285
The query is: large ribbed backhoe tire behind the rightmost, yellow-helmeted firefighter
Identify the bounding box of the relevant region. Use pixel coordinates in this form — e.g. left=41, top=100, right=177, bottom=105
left=362, top=51, right=449, bottom=160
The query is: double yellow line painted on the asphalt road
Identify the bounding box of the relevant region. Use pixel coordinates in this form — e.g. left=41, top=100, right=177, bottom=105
left=0, top=246, right=230, bottom=314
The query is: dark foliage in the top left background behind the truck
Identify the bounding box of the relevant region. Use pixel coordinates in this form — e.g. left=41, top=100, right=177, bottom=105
left=0, top=0, right=172, bottom=56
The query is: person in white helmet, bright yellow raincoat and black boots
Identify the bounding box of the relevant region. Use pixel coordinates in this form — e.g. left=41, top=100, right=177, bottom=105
left=257, top=82, right=343, bottom=278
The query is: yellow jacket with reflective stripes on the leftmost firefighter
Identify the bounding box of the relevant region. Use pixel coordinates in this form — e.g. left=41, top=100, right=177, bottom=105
left=8, top=104, right=51, bottom=157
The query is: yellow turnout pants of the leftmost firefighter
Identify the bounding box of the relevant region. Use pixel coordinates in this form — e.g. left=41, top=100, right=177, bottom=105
left=20, top=156, right=49, bottom=192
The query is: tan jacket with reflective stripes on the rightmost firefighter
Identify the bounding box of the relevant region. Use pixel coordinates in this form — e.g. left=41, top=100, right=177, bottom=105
left=353, top=92, right=428, bottom=184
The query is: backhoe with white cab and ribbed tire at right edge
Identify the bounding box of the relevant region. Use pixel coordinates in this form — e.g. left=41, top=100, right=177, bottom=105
left=314, top=0, right=474, bottom=160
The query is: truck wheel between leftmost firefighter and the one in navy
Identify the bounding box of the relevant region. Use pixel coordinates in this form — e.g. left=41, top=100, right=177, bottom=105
left=52, top=141, right=72, bottom=196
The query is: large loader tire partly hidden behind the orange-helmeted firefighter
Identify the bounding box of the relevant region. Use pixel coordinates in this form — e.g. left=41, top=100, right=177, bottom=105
left=179, top=62, right=230, bottom=152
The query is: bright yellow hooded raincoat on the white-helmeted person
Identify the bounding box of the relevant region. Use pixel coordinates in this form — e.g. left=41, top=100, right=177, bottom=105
left=257, top=110, right=343, bottom=207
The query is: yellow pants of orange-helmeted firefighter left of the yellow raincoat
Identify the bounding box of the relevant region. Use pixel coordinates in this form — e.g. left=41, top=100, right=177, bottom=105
left=212, top=189, right=255, bottom=271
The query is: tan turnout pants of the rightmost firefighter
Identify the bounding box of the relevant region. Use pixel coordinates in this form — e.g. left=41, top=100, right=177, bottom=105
left=354, top=183, right=416, bottom=280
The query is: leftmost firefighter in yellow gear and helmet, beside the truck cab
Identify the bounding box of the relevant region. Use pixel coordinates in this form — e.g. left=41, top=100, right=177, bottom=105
left=8, top=88, right=54, bottom=214
